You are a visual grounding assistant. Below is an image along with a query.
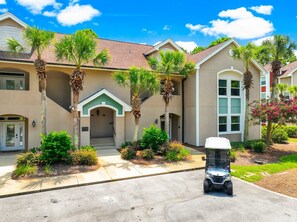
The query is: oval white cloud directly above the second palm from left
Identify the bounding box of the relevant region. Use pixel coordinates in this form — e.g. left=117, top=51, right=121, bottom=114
left=57, top=4, right=101, bottom=26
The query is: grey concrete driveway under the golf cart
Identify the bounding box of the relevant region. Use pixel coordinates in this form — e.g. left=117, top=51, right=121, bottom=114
left=0, top=170, right=297, bottom=222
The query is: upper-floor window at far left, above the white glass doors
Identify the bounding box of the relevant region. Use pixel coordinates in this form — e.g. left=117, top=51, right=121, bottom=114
left=0, top=73, right=26, bottom=90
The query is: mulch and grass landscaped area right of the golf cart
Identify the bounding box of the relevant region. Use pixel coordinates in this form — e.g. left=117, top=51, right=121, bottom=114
left=231, top=140, right=297, bottom=198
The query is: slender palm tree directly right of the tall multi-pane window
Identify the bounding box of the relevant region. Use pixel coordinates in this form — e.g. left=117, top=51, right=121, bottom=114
left=233, top=43, right=256, bottom=141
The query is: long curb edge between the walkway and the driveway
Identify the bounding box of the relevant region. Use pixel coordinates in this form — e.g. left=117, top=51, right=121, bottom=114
left=0, top=167, right=205, bottom=199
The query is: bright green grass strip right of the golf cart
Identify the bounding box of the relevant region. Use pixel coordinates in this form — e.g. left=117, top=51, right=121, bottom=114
left=231, top=154, right=297, bottom=183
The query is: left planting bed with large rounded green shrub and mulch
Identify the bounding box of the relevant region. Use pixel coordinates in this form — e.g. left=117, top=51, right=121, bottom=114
left=11, top=131, right=100, bottom=179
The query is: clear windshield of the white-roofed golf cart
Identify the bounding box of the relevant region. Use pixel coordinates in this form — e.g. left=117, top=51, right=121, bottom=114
left=206, top=149, right=230, bottom=169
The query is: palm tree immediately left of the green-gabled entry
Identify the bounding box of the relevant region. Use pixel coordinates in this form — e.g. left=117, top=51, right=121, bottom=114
left=55, top=30, right=109, bottom=148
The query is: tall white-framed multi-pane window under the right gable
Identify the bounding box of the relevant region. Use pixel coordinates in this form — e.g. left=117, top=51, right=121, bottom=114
left=218, top=79, right=242, bottom=134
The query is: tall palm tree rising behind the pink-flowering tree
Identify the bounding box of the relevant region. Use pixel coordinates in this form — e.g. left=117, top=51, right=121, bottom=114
left=262, top=35, right=296, bottom=146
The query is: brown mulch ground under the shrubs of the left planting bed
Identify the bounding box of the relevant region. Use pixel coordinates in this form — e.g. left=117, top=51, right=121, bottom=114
left=11, top=163, right=100, bottom=180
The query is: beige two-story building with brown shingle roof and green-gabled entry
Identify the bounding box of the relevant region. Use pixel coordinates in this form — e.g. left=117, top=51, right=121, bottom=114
left=0, top=13, right=267, bottom=151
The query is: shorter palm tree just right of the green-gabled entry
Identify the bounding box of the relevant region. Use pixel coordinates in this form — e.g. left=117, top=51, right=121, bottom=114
left=112, top=67, right=160, bottom=146
